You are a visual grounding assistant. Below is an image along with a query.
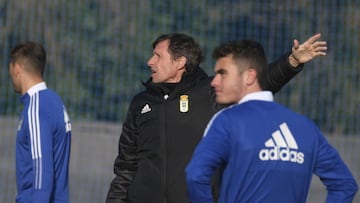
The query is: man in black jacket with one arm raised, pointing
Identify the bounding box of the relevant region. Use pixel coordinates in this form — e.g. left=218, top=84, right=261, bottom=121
left=107, top=33, right=326, bottom=203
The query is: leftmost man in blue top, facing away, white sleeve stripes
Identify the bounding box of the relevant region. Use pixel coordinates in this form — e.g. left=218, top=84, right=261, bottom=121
left=9, top=42, right=71, bottom=203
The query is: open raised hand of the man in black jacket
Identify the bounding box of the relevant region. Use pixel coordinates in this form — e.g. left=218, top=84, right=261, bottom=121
left=289, top=33, right=327, bottom=67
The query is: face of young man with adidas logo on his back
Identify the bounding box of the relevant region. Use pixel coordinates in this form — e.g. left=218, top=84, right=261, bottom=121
left=211, top=56, right=245, bottom=104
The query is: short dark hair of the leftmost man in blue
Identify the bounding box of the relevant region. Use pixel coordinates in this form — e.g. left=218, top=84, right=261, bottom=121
left=10, top=41, right=46, bottom=76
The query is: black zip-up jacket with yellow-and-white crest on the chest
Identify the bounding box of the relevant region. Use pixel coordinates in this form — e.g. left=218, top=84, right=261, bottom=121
left=107, top=55, right=302, bottom=203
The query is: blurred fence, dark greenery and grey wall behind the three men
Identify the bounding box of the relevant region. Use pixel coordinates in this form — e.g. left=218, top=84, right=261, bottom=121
left=0, top=0, right=360, bottom=203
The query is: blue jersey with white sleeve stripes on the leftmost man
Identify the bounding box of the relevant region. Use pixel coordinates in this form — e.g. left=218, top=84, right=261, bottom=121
left=16, top=82, right=71, bottom=203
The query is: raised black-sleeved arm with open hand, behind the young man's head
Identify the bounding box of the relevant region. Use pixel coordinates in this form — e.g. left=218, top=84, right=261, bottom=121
left=266, top=34, right=327, bottom=93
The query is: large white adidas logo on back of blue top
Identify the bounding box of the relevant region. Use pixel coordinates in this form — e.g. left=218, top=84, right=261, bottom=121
left=259, top=123, right=304, bottom=164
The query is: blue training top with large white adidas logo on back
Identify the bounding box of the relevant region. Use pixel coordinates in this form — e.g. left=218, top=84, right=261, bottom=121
left=186, top=100, right=357, bottom=203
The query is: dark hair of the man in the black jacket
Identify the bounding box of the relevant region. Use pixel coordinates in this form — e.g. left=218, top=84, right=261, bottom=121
left=152, top=33, right=204, bottom=72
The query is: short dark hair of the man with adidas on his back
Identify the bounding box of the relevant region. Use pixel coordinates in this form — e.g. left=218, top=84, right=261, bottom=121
left=212, top=40, right=267, bottom=89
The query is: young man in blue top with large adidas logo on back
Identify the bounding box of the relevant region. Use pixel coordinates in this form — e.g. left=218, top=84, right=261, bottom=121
left=186, top=40, right=358, bottom=203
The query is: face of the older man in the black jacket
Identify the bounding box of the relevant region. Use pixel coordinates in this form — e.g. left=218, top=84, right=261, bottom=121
left=147, top=40, right=184, bottom=83
